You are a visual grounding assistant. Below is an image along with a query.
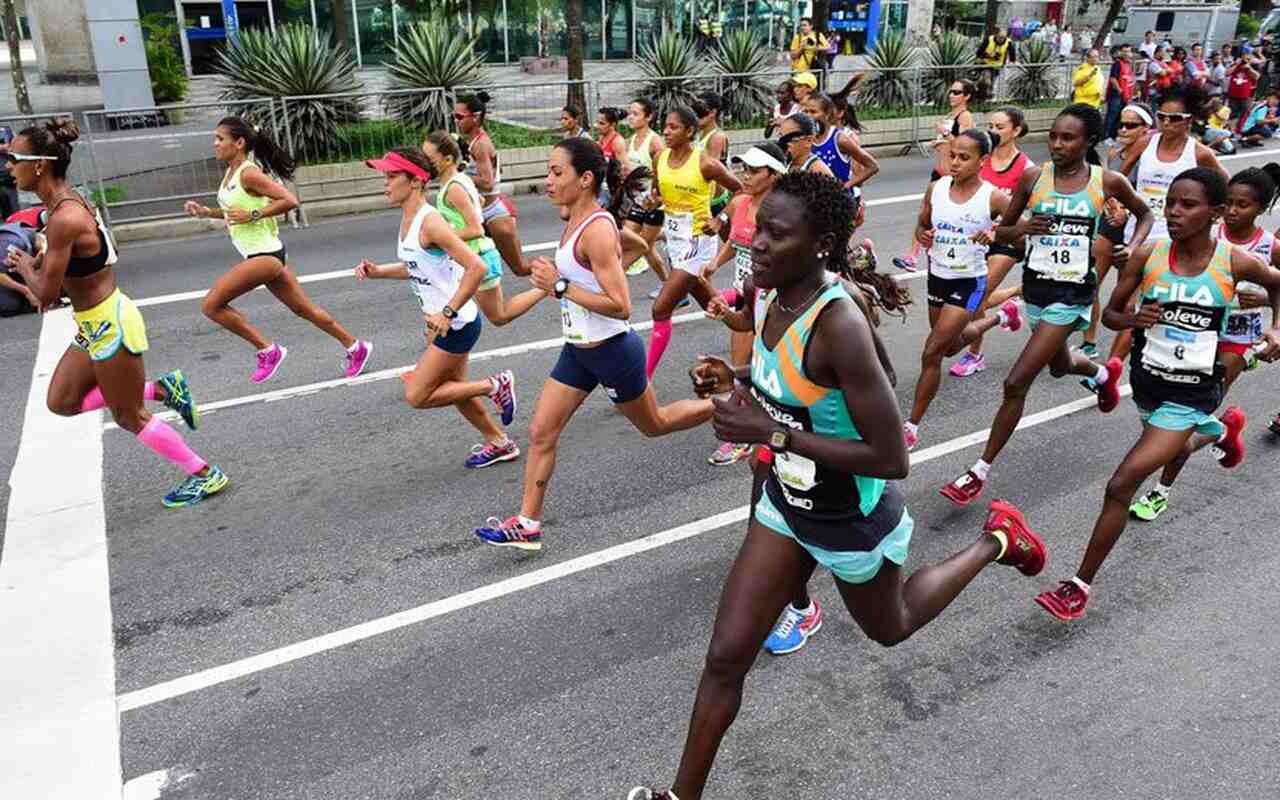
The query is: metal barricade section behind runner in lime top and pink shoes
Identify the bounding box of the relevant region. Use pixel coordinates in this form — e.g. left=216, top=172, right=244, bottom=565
left=83, top=97, right=279, bottom=223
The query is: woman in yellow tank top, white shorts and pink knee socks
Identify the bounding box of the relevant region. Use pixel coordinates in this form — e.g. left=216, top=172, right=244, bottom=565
left=645, top=106, right=742, bottom=378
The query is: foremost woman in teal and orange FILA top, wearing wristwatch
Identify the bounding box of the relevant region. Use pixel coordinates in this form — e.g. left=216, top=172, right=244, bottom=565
left=628, top=173, right=1046, bottom=800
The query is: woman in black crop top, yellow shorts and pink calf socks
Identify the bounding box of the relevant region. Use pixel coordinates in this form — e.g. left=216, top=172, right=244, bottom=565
left=5, top=119, right=227, bottom=508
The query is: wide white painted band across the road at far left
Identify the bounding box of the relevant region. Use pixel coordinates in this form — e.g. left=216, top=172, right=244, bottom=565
left=0, top=308, right=122, bottom=800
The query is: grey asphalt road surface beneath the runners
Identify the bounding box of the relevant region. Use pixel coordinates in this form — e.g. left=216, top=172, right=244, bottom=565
left=0, top=140, right=1280, bottom=800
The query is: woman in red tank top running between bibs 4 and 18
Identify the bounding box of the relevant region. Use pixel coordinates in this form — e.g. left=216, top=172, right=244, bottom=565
left=950, top=106, right=1032, bottom=378
